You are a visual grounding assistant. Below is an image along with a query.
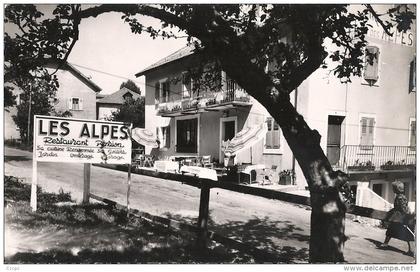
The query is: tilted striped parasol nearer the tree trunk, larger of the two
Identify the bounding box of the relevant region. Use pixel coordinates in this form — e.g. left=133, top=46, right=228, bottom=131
left=224, top=123, right=267, bottom=157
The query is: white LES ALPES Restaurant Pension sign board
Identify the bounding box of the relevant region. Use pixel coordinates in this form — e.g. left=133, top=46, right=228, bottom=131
left=34, top=115, right=131, bottom=164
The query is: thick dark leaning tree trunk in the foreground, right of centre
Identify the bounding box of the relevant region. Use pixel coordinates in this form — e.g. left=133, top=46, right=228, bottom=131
left=273, top=102, right=346, bottom=263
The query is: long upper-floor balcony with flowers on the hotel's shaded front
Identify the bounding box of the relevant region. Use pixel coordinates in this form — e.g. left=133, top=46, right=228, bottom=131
left=158, top=82, right=252, bottom=117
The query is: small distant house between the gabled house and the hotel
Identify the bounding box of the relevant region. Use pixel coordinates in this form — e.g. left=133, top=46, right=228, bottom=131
left=96, top=87, right=140, bottom=120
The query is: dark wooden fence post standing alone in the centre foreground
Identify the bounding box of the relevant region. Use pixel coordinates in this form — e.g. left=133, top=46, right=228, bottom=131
left=197, top=183, right=210, bottom=249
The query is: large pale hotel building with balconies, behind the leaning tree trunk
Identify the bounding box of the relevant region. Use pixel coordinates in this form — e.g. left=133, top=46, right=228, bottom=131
left=136, top=5, right=416, bottom=206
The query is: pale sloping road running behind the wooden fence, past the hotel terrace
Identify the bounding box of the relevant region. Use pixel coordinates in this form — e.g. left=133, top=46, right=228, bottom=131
left=4, top=147, right=415, bottom=263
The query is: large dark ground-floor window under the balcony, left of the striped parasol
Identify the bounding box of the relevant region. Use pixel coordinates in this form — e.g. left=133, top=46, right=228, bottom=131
left=176, top=118, right=198, bottom=153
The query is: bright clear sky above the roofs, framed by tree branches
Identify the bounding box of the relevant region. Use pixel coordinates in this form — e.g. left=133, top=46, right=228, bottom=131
left=5, top=4, right=187, bottom=95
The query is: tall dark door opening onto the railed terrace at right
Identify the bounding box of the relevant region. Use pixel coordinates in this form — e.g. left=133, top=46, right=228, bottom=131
left=327, top=115, right=344, bottom=165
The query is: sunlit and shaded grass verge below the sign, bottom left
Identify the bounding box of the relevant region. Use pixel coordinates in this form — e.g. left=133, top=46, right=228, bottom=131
left=4, top=176, right=255, bottom=264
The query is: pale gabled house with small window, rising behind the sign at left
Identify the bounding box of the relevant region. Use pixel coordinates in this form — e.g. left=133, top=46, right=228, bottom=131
left=4, top=63, right=102, bottom=139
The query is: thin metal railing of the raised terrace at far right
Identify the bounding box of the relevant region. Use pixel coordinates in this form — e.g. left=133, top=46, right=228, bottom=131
left=339, top=145, right=416, bottom=171
